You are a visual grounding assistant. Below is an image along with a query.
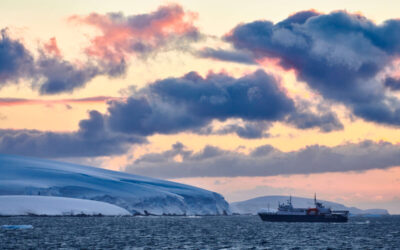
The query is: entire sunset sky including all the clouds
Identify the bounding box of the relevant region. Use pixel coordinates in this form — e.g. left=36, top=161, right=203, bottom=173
left=0, top=0, right=400, bottom=214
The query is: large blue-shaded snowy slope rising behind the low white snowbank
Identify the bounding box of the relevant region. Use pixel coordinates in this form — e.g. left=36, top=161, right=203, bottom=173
left=0, top=154, right=230, bottom=215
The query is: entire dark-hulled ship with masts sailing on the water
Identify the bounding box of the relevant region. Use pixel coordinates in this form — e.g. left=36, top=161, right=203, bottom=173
left=258, top=194, right=349, bottom=222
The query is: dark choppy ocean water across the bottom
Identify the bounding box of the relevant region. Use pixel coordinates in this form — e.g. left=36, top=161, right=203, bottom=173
left=0, top=216, right=400, bottom=249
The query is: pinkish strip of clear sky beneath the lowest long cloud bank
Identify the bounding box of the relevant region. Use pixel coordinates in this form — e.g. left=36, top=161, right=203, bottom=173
left=173, top=167, right=400, bottom=210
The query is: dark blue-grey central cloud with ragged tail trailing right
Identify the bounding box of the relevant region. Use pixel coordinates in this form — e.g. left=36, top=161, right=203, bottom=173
left=108, top=70, right=343, bottom=138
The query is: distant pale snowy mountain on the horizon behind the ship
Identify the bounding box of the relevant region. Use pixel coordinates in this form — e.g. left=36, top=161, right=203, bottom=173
left=230, top=196, right=389, bottom=215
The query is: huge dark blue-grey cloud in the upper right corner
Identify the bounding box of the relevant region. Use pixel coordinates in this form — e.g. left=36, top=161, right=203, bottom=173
left=224, top=11, right=400, bottom=126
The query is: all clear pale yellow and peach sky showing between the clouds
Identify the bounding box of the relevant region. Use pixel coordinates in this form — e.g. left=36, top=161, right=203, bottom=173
left=0, top=0, right=400, bottom=213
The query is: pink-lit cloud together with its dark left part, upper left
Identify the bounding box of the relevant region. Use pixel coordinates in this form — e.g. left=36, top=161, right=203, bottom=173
left=0, top=4, right=202, bottom=95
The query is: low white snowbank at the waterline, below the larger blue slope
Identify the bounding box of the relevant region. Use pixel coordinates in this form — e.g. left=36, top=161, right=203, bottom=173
left=0, top=195, right=131, bottom=216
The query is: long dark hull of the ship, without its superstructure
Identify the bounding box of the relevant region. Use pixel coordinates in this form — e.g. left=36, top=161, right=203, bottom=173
left=258, top=213, right=348, bottom=222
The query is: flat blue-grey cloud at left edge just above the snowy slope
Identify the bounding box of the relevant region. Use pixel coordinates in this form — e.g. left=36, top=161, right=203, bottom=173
left=0, top=111, right=146, bottom=158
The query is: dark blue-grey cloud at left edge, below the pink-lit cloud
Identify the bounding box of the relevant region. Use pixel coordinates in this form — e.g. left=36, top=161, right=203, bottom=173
left=0, top=29, right=125, bottom=94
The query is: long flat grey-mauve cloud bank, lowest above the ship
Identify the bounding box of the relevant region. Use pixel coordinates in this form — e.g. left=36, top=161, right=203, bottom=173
left=125, top=141, right=400, bottom=178
